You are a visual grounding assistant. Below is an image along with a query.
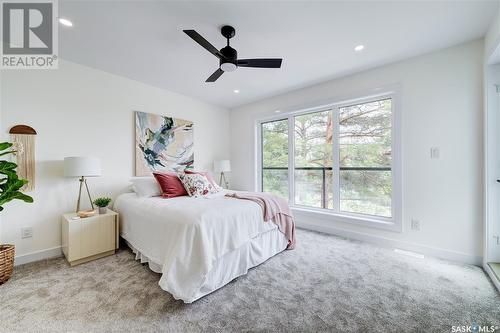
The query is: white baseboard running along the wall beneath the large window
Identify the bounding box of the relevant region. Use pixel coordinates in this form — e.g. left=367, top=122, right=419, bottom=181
left=295, top=220, right=483, bottom=266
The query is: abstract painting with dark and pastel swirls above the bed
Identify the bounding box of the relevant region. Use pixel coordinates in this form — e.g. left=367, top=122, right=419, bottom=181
left=135, top=111, right=194, bottom=176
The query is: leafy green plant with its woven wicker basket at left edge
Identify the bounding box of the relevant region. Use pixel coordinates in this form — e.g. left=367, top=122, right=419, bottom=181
left=0, top=142, right=33, bottom=285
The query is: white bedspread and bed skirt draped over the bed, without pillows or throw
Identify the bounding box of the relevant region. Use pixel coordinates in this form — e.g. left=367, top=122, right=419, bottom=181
left=114, top=191, right=288, bottom=303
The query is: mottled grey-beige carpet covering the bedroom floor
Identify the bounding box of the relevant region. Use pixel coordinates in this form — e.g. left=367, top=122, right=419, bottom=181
left=0, top=230, right=500, bottom=332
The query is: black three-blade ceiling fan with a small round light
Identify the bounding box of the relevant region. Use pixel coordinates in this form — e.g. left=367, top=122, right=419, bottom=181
left=183, top=25, right=283, bottom=82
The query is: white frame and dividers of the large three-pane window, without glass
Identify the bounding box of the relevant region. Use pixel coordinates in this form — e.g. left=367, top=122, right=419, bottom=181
left=255, top=87, right=403, bottom=232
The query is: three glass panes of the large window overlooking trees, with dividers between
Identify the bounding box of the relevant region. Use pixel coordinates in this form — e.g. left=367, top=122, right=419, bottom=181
left=260, top=94, right=399, bottom=226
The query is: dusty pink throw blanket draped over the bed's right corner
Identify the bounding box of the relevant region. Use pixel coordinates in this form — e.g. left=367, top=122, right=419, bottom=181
left=226, top=192, right=295, bottom=250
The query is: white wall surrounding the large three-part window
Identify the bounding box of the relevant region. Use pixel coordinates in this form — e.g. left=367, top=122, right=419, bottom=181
left=230, top=40, right=483, bottom=264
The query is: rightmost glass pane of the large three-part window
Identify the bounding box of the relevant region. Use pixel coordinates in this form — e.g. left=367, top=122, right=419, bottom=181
left=338, top=99, right=392, bottom=217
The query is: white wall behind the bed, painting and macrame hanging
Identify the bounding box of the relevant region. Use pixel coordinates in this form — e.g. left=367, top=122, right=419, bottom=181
left=0, top=61, right=229, bottom=263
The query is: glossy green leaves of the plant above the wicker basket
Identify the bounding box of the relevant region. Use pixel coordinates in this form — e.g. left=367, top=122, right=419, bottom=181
left=0, top=142, right=33, bottom=211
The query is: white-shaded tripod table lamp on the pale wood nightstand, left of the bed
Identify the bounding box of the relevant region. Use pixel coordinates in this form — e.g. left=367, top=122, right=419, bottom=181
left=64, top=156, right=101, bottom=212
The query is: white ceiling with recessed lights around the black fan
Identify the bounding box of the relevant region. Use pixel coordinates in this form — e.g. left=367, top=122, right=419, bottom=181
left=59, top=1, right=498, bottom=108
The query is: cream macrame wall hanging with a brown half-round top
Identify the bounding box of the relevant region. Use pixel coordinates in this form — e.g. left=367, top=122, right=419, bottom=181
left=9, top=125, right=36, bottom=192
